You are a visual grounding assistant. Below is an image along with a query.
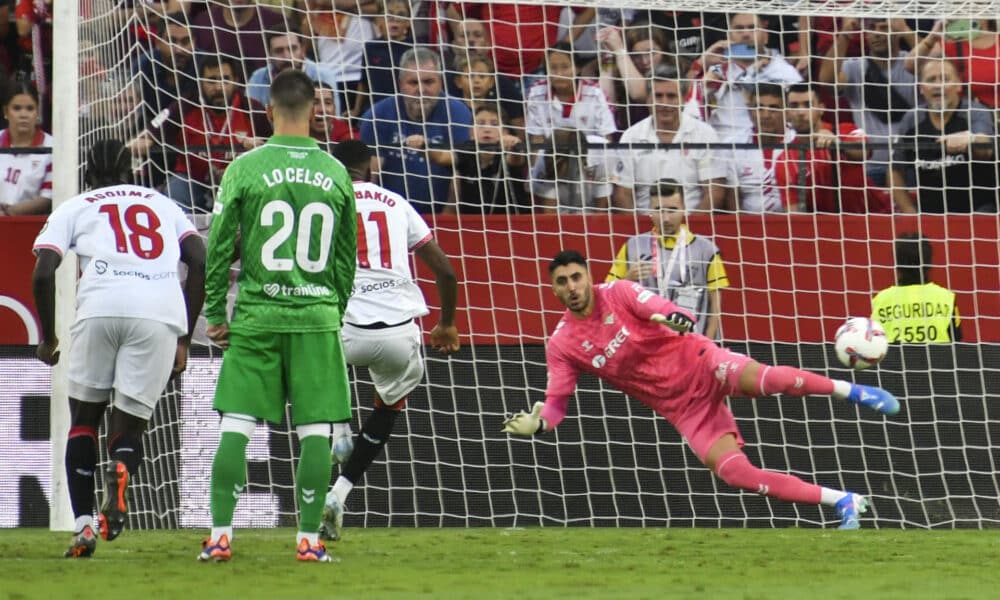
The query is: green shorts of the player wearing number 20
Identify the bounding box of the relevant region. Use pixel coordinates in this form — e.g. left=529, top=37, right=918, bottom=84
left=212, top=331, right=351, bottom=425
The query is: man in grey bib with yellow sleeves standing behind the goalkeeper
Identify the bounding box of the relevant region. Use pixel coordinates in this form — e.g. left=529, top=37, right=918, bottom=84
left=607, top=179, right=729, bottom=340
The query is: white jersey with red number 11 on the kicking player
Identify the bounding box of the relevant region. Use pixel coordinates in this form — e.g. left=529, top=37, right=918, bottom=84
left=344, top=181, right=433, bottom=325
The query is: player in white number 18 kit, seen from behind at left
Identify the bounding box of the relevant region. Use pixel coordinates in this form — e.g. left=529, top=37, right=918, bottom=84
left=32, top=140, right=205, bottom=557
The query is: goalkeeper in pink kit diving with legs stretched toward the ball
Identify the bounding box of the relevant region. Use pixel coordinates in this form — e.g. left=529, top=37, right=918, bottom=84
left=503, top=250, right=899, bottom=529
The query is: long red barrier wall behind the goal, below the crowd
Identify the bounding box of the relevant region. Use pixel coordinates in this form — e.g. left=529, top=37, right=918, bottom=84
left=0, top=215, right=1000, bottom=344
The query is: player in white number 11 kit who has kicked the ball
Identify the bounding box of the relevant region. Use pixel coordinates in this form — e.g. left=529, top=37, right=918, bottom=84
left=320, top=140, right=459, bottom=540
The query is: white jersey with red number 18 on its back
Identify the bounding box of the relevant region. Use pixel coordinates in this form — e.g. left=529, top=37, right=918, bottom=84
left=34, top=185, right=198, bottom=335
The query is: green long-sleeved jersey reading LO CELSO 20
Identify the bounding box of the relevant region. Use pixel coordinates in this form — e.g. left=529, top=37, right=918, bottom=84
left=205, top=136, right=358, bottom=332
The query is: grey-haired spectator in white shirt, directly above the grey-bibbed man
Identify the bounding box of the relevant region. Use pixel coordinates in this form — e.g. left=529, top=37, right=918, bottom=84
left=612, top=65, right=727, bottom=210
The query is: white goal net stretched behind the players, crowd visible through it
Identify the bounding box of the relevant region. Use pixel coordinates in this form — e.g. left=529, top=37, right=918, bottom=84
left=53, top=0, right=1000, bottom=528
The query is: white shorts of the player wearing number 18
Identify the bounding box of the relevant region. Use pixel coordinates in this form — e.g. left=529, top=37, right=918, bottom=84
left=69, top=317, right=177, bottom=420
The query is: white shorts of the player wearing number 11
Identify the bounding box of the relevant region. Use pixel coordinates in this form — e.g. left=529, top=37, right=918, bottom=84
left=340, top=321, right=424, bottom=406
